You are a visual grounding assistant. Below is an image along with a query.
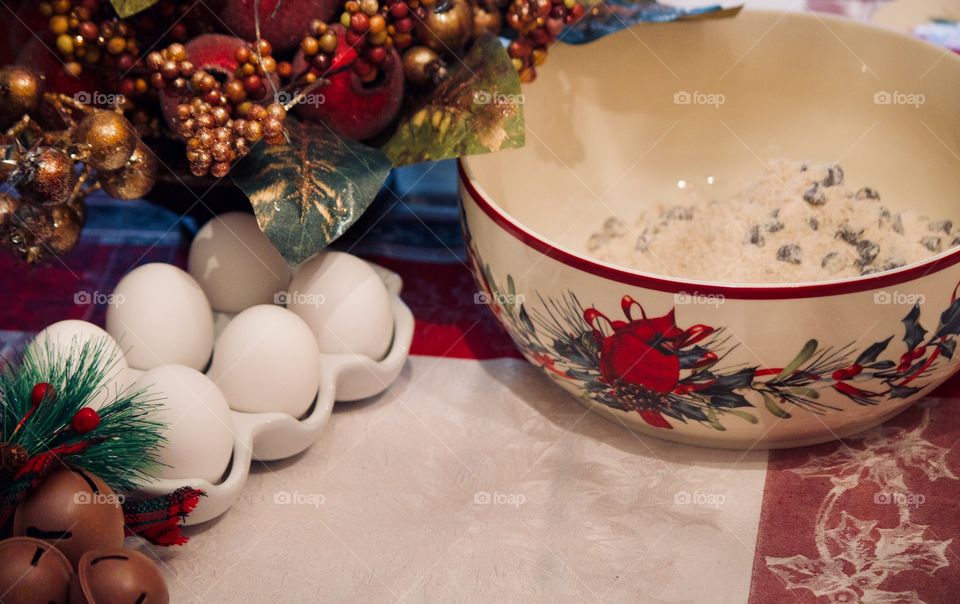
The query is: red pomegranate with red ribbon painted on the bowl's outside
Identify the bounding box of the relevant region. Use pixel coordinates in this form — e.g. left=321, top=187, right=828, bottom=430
left=583, top=296, right=716, bottom=429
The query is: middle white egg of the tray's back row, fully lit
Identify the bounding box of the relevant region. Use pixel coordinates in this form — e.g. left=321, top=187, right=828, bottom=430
left=107, top=263, right=213, bottom=369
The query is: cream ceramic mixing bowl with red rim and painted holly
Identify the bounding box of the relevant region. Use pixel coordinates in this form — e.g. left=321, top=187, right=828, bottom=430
left=460, top=12, right=960, bottom=448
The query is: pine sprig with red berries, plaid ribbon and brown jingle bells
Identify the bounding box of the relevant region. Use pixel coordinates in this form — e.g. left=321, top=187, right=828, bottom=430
left=0, top=339, right=203, bottom=603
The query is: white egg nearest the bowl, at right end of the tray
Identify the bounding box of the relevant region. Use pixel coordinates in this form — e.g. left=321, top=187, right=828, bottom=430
left=287, top=252, right=393, bottom=360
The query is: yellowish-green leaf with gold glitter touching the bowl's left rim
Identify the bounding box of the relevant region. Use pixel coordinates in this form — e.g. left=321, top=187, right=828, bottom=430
left=382, top=34, right=524, bottom=166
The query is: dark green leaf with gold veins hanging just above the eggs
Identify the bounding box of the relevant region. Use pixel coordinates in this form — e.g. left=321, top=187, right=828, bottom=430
left=231, top=120, right=390, bottom=264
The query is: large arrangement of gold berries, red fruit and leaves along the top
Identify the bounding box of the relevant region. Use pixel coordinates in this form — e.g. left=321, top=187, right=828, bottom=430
left=0, top=0, right=735, bottom=264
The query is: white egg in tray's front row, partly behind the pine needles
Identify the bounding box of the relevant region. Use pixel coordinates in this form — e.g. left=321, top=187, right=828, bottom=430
left=133, top=365, right=235, bottom=484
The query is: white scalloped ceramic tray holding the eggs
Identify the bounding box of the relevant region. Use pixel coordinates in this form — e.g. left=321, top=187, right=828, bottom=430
left=137, top=263, right=414, bottom=525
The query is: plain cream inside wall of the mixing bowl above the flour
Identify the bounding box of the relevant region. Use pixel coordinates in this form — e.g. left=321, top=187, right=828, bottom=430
left=465, top=11, right=960, bottom=262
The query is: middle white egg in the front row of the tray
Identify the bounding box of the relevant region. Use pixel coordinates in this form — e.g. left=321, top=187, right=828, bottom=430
left=207, top=304, right=320, bottom=418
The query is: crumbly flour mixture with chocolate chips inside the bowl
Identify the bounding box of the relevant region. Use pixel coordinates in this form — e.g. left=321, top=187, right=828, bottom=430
left=587, top=160, right=960, bottom=283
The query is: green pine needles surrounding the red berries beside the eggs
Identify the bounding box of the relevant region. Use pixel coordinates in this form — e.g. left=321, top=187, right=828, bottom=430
left=0, top=338, right=164, bottom=491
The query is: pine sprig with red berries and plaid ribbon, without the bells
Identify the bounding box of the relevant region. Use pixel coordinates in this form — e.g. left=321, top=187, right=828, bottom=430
left=0, top=340, right=201, bottom=545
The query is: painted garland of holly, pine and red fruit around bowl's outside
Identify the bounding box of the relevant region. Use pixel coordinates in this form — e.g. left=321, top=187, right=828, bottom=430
left=468, top=228, right=960, bottom=431
